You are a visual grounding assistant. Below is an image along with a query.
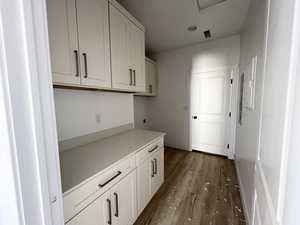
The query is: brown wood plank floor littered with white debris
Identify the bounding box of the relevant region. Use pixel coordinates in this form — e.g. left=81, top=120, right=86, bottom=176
left=134, top=148, right=246, bottom=225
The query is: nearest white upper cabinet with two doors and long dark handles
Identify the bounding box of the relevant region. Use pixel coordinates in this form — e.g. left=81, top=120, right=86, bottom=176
left=47, top=0, right=111, bottom=88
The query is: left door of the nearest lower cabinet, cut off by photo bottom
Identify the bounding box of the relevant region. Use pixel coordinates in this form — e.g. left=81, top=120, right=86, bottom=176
left=66, top=192, right=111, bottom=225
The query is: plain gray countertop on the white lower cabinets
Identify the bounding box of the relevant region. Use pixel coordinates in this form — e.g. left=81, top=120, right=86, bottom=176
left=60, top=129, right=164, bottom=192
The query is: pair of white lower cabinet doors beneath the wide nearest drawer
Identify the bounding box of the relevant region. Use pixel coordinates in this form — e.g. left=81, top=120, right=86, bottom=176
left=67, top=170, right=137, bottom=225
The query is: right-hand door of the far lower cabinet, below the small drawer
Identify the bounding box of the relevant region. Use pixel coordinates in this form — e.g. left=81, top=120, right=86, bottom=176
left=150, top=148, right=164, bottom=197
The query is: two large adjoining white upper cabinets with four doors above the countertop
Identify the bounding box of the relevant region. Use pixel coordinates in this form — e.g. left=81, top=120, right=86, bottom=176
left=47, top=0, right=145, bottom=92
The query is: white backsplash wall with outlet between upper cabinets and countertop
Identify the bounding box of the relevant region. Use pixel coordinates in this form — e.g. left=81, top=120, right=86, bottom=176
left=54, top=89, right=134, bottom=141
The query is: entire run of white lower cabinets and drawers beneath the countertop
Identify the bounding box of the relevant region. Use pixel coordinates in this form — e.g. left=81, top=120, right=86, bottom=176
left=64, top=138, right=164, bottom=225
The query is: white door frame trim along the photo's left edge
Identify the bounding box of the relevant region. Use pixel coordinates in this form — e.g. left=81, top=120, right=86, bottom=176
left=0, top=0, right=64, bottom=225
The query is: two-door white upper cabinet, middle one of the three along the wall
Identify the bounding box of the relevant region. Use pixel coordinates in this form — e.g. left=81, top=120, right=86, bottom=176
left=110, top=4, right=145, bottom=92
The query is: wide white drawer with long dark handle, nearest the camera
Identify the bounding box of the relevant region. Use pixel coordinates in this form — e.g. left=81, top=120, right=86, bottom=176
left=63, top=156, right=135, bottom=222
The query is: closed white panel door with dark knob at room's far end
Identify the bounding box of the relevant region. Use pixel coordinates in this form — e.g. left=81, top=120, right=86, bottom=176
left=191, top=69, right=232, bottom=156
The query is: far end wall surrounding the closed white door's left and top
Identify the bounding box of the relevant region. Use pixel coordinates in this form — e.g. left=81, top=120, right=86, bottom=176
left=149, top=35, right=240, bottom=150
